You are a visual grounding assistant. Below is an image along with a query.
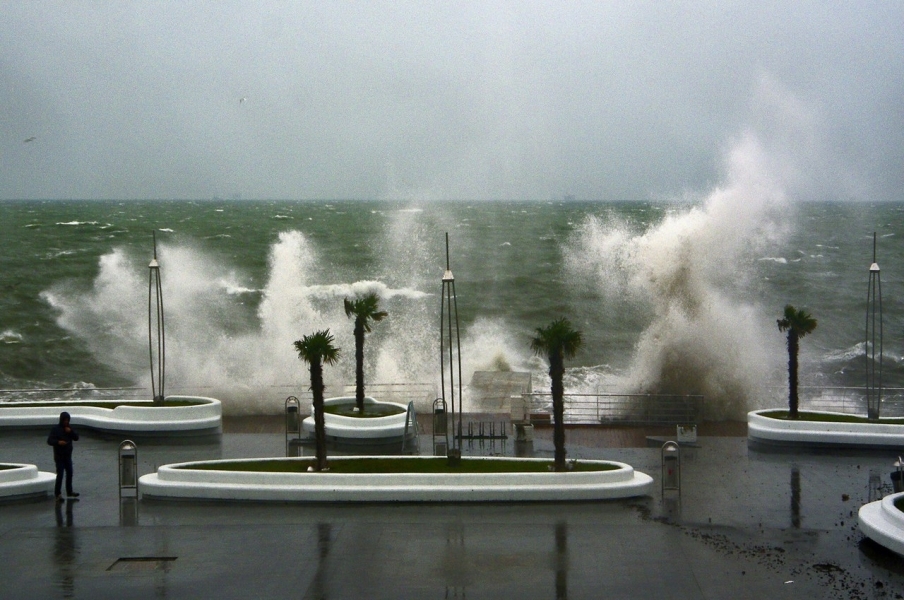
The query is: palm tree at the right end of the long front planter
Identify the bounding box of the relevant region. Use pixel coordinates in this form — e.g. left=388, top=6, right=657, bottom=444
left=530, top=317, right=583, bottom=471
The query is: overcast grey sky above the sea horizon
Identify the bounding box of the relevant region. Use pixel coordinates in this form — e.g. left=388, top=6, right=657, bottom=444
left=0, top=0, right=904, bottom=200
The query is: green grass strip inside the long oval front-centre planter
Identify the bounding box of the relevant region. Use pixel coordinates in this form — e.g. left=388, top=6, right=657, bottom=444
left=180, top=456, right=620, bottom=474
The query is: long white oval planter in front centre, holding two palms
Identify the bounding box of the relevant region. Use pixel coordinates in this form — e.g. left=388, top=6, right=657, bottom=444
left=139, top=456, right=653, bottom=502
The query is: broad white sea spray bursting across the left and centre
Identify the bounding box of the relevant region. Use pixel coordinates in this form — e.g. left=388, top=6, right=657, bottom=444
left=42, top=211, right=536, bottom=415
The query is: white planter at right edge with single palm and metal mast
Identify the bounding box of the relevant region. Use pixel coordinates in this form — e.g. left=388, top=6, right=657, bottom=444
left=747, top=409, right=904, bottom=448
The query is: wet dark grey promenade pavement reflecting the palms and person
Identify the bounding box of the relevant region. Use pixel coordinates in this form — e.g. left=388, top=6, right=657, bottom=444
left=0, top=419, right=904, bottom=599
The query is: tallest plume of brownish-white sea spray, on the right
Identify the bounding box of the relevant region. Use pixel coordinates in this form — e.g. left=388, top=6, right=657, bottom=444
left=565, top=135, right=790, bottom=419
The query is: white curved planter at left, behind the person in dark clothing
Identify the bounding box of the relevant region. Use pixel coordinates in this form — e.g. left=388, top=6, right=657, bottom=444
left=0, top=396, right=223, bottom=434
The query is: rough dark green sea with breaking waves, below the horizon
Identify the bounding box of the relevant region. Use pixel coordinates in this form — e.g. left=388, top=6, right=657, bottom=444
left=0, top=199, right=904, bottom=414
